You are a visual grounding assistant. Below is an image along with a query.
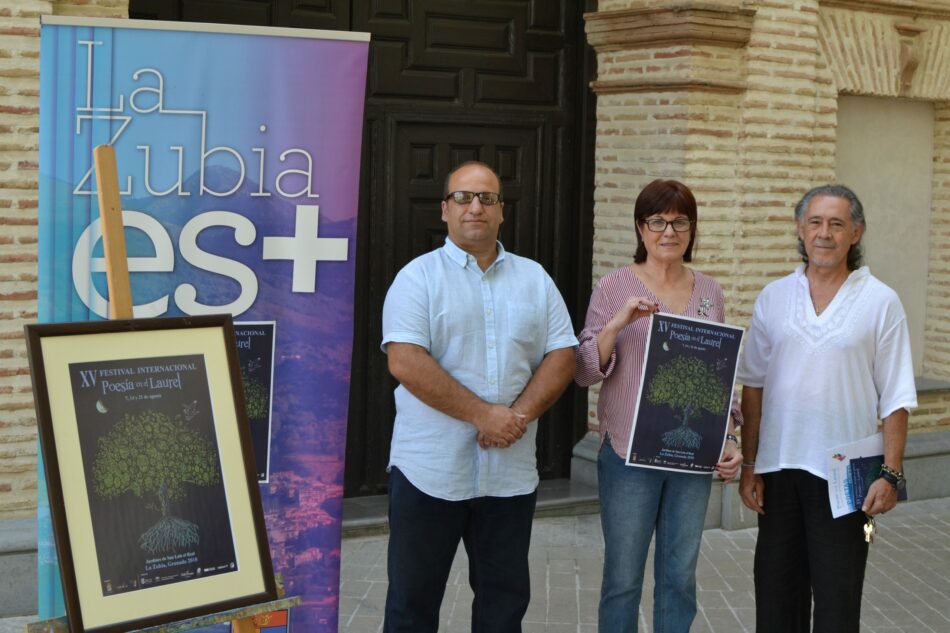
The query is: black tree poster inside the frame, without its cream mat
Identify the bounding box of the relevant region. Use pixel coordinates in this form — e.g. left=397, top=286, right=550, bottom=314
left=69, top=354, right=238, bottom=596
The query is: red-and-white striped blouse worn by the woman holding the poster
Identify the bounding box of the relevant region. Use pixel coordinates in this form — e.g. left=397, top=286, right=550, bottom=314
left=574, top=266, right=742, bottom=457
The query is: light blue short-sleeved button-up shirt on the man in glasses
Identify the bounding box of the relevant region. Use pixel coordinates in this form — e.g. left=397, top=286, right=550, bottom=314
left=382, top=239, right=577, bottom=501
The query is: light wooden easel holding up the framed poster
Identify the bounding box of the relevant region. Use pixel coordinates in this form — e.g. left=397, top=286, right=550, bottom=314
left=24, top=145, right=301, bottom=633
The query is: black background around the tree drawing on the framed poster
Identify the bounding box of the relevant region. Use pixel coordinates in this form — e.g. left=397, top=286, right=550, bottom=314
left=69, top=355, right=237, bottom=595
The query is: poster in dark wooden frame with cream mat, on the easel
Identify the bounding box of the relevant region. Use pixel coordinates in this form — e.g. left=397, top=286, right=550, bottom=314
left=25, top=315, right=277, bottom=633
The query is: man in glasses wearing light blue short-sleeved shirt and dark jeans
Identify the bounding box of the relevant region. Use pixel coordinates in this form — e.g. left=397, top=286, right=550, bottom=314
left=382, top=162, right=577, bottom=633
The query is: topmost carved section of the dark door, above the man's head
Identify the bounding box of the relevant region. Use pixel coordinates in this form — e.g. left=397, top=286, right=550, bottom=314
left=353, top=0, right=579, bottom=111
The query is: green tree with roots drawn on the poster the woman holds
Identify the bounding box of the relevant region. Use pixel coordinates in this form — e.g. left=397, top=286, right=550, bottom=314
left=647, top=357, right=727, bottom=450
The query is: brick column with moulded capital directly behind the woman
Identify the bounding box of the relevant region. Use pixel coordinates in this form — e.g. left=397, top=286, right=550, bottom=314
left=586, top=1, right=755, bottom=428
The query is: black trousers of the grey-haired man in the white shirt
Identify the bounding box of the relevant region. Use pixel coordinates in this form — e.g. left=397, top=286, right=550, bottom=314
left=755, top=470, right=868, bottom=633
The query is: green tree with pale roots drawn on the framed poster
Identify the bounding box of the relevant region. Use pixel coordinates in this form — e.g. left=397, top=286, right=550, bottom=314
left=92, top=410, right=221, bottom=554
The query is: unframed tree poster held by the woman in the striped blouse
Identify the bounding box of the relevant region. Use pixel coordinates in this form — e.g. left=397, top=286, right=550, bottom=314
left=627, top=313, right=744, bottom=473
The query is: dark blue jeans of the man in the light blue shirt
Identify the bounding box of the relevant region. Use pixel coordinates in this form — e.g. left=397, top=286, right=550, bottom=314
left=383, top=468, right=537, bottom=633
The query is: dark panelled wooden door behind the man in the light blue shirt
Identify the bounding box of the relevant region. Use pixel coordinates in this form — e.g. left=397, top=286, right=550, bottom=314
left=129, top=0, right=595, bottom=496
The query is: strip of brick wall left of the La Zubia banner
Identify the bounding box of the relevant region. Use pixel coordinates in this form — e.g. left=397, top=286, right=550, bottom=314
left=0, top=0, right=128, bottom=518
